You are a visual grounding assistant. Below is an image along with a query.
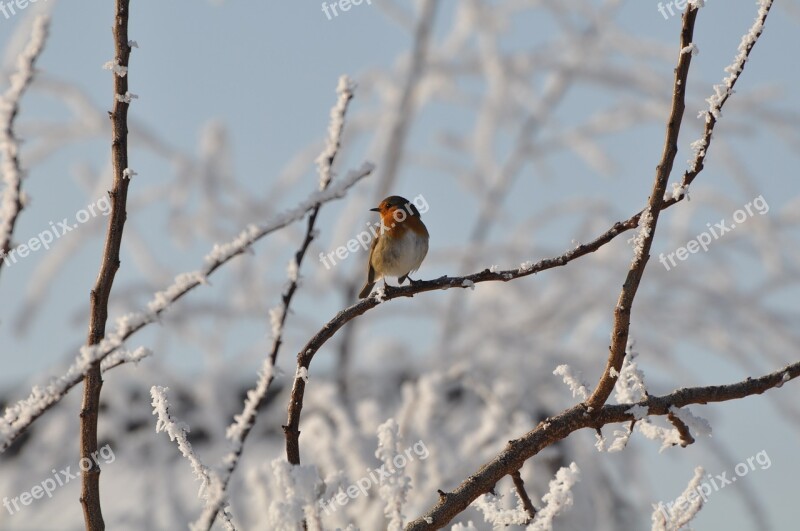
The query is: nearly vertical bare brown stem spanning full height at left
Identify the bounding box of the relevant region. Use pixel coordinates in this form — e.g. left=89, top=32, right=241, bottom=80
left=80, top=0, right=132, bottom=531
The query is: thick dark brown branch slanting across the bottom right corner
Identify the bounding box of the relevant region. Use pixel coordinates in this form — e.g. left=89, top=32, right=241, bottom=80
left=406, top=362, right=800, bottom=531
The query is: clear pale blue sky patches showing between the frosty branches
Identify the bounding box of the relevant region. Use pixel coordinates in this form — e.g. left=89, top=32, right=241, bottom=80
left=0, top=0, right=800, bottom=530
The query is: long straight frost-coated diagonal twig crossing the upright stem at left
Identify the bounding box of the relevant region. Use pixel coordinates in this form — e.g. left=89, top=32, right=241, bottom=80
left=0, top=163, right=373, bottom=453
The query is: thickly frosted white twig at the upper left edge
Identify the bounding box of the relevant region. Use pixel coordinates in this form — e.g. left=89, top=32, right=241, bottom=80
left=0, top=15, right=50, bottom=278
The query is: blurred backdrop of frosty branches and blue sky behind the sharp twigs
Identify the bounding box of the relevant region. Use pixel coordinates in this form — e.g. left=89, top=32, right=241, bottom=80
left=0, top=0, right=800, bottom=530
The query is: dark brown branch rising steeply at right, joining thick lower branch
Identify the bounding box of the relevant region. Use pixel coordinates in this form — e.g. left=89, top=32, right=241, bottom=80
left=586, top=4, right=697, bottom=411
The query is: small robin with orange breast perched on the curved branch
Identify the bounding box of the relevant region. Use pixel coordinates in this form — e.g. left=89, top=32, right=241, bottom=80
left=358, top=195, right=429, bottom=299
